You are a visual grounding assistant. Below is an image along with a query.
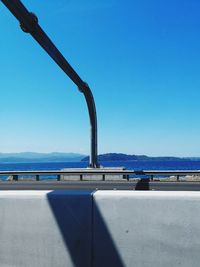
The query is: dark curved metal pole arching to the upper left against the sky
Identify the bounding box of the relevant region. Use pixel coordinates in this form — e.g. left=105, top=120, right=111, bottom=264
left=1, top=0, right=98, bottom=168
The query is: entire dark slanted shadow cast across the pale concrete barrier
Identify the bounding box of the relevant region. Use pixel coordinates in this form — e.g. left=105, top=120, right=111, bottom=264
left=47, top=190, right=124, bottom=267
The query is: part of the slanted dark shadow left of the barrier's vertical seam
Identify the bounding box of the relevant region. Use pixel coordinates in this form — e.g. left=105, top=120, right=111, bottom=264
left=47, top=190, right=92, bottom=267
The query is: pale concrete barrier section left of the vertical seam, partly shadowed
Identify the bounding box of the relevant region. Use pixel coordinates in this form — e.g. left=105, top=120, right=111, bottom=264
left=0, top=191, right=92, bottom=267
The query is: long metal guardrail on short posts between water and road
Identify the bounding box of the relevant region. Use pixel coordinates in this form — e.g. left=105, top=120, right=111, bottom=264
left=0, top=172, right=200, bottom=181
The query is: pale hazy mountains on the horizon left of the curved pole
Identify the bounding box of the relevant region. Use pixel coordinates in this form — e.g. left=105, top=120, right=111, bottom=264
left=0, top=152, right=85, bottom=163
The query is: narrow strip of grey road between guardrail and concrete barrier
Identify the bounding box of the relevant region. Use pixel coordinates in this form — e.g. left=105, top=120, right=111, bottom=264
left=0, top=181, right=200, bottom=191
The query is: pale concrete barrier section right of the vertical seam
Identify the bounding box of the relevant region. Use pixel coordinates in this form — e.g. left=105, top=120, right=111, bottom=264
left=93, top=191, right=200, bottom=267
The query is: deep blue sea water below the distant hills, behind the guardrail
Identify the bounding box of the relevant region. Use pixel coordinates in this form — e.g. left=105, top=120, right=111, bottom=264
left=0, top=160, right=200, bottom=180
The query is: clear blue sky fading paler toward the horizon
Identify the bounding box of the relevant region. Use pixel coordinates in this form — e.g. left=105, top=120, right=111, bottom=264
left=0, top=0, right=200, bottom=156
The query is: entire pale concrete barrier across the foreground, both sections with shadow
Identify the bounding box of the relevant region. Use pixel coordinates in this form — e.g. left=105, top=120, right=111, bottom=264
left=0, top=191, right=200, bottom=267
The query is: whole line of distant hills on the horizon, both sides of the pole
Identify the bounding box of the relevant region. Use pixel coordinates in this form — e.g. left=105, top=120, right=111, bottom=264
left=0, top=152, right=200, bottom=163
